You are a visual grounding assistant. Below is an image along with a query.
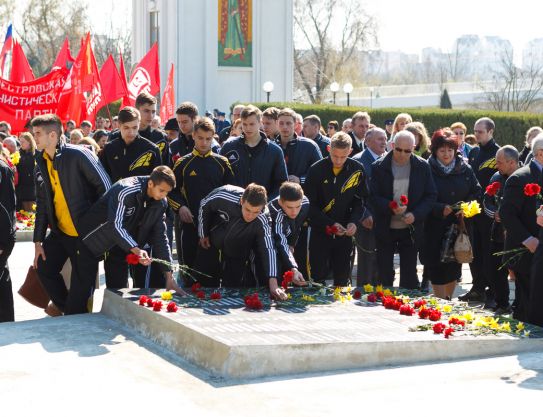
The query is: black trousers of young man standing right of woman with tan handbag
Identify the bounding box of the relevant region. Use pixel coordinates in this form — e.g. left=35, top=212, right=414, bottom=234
left=469, top=215, right=496, bottom=294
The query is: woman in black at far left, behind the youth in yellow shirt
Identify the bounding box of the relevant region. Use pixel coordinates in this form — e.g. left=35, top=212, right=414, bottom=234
left=16, top=132, right=36, bottom=211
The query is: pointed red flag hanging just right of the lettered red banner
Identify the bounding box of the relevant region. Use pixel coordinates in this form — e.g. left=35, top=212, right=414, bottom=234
left=57, top=33, right=105, bottom=125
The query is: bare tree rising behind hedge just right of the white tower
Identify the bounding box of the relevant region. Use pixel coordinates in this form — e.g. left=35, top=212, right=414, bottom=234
left=294, top=0, right=376, bottom=103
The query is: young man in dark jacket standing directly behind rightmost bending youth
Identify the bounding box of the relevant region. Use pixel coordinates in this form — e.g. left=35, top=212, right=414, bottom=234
left=276, top=108, right=322, bottom=279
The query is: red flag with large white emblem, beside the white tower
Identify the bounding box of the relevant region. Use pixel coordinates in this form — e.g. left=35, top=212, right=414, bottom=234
left=128, top=42, right=160, bottom=106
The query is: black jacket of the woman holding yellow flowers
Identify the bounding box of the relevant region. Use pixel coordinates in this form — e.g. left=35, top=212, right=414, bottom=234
left=421, top=156, right=481, bottom=265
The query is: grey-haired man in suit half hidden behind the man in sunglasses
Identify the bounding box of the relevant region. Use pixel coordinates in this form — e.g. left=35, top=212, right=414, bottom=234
left=353, top=127, right=387, bottom=287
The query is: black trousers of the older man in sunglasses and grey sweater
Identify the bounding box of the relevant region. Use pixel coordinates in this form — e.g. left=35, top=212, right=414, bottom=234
left=376, top=228, right=419, bottom=289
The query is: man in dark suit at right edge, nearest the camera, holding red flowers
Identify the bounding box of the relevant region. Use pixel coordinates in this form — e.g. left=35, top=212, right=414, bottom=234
left=499, top=136, right=543, bottom=321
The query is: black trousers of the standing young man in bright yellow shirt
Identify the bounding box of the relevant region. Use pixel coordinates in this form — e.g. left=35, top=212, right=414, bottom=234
left=37, top=232, right=98, bottom=314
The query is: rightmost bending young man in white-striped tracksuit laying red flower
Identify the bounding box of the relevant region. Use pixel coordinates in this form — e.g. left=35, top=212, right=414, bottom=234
left=268, top=182, right=309, bottom=285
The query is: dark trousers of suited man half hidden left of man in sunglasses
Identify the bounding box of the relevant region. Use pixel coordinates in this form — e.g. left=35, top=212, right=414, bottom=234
left=355, top=225, right=379, bottom=287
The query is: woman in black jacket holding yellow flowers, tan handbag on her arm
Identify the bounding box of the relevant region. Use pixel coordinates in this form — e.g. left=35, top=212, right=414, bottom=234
left=421, top=130, right=481, bottom=299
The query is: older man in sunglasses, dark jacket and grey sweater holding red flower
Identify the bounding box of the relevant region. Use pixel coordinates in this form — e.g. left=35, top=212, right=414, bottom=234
left=370, top=130, right=437, bottom=289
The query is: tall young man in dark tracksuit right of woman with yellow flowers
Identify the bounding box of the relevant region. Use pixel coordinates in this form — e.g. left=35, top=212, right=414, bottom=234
left=464, top=117, right=500, bottom=305
